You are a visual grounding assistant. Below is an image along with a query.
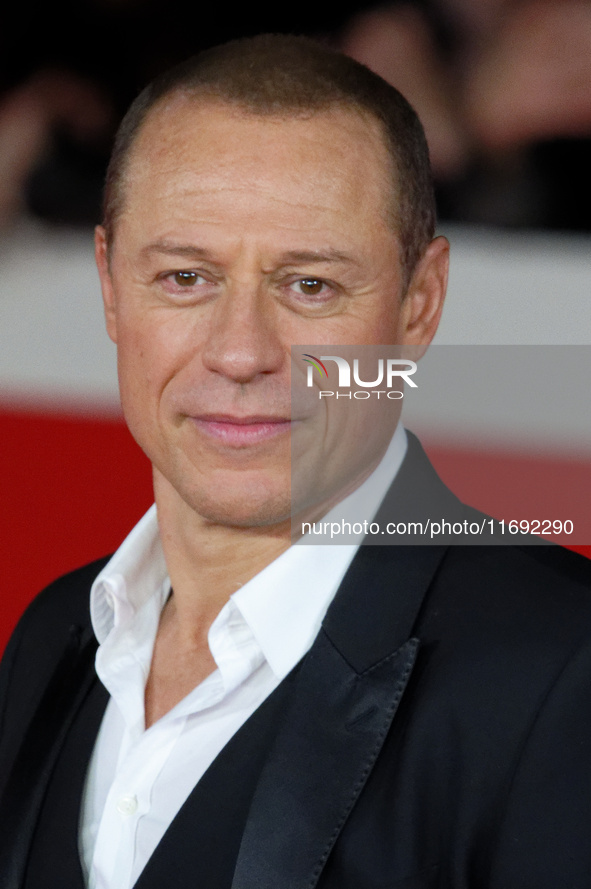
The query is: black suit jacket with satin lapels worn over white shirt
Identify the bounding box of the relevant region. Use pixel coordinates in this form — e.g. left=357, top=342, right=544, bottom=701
left=0, top=439, right=591, bottom=889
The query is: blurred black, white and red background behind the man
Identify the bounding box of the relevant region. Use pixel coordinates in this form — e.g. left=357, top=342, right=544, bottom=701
left=0, top=0, right=591, bottom=648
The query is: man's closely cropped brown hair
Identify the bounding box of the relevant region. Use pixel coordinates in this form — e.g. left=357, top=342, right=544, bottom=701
left=103, top=34, right=435, bottom=283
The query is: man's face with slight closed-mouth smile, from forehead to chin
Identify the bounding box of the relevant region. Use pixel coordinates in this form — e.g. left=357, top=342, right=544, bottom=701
left=97, top=96, right=448, bottom=526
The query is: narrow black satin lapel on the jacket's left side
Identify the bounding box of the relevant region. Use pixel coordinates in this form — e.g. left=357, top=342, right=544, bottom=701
left=0, top=627, right=96, bottom=889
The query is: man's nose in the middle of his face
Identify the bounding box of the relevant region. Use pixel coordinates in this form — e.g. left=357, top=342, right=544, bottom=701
left=203, top=282, right=289, bottom=384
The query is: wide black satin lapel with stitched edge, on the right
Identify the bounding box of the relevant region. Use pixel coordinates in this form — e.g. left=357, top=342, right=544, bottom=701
left=232, top=546, right=445, bottom=889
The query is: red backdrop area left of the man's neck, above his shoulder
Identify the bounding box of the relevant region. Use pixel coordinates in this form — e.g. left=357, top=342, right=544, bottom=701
left=0, top=411, right=152, bottom=650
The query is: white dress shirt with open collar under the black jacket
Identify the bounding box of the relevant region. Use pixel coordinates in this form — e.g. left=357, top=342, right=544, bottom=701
left=79, top=426, right=406, bottom=889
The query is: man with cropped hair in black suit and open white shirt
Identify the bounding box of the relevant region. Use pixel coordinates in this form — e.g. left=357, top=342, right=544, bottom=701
left=0, top=36, right=591, bottom=889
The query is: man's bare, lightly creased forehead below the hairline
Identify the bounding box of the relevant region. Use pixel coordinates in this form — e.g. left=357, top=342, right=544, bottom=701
left=123, top=95, right=393, bottom=239
